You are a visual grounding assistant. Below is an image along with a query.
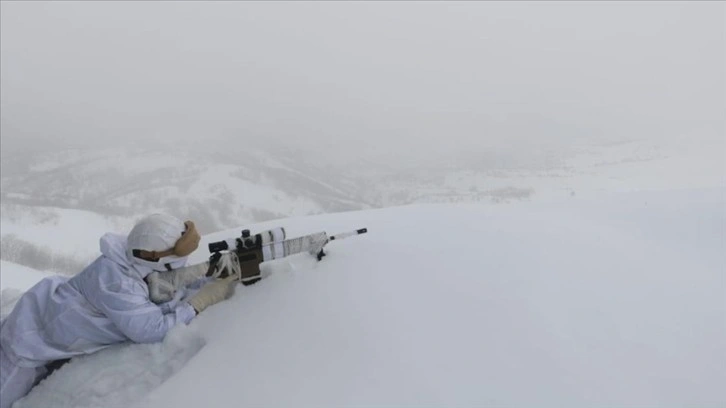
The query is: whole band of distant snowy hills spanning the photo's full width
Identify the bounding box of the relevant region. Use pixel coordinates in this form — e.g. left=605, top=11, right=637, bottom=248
left=0, top=141, right=726, bottom=274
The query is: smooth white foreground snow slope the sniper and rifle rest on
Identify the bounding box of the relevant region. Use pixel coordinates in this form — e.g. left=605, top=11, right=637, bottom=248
left=3, top=189, right=726, bottom=408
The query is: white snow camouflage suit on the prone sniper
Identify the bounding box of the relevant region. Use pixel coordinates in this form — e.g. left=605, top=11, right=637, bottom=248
left=0, top=233, right=201, bottom=408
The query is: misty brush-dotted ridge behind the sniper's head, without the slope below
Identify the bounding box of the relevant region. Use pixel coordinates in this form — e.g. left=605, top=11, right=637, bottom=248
left=2, top=149, right=367, bottom=231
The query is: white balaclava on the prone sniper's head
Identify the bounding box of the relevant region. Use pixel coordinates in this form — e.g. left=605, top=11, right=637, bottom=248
left=126, top=214, right=187, bottom=271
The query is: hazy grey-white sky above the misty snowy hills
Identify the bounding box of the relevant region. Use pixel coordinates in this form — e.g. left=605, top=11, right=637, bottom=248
left=0, top=1, right=726, bottom=164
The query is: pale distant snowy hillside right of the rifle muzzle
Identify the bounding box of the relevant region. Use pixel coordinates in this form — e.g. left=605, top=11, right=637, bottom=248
left=362, top=137, right=726, bottom=206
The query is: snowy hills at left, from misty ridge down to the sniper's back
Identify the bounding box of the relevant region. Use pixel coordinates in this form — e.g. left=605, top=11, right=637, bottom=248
left=0, top=148, right=371, bottom=274
